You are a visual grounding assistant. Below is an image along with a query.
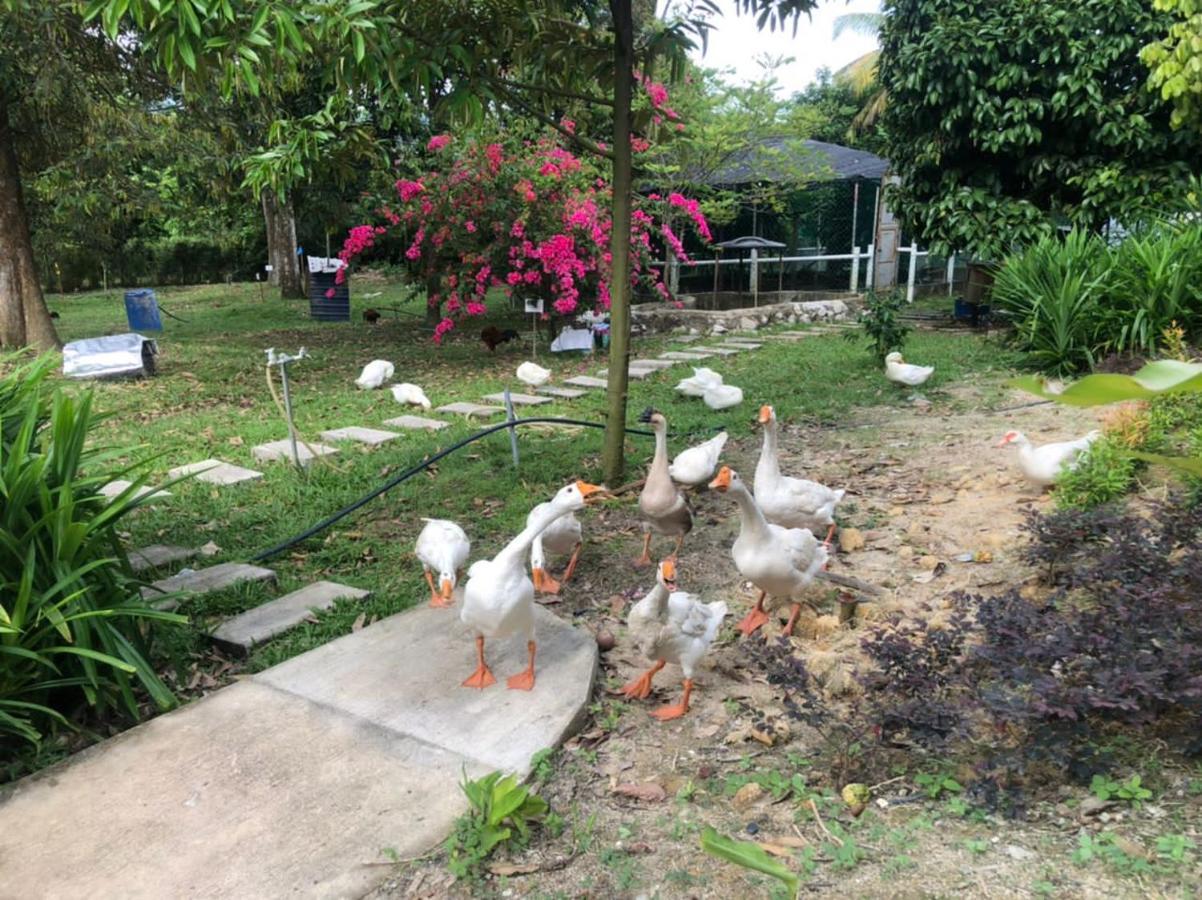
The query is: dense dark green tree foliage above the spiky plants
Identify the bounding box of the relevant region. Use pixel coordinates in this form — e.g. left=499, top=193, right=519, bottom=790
left=880, top=0, right=1197, bottom=258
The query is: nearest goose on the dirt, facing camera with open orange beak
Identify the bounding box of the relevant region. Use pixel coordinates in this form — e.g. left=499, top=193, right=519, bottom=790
left=621, top=559, right=726, bottom=721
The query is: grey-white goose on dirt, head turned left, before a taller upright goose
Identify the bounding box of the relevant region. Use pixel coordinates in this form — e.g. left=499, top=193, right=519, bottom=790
left=709, top=466, right=827, bottom=634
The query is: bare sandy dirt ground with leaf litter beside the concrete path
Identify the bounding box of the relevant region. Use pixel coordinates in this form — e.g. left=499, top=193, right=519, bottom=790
left=375, top=388, right=1202, bottom=898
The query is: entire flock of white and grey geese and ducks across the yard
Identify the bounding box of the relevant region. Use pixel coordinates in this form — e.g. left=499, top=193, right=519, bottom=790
left=372, top=341, right=1096, bottom=720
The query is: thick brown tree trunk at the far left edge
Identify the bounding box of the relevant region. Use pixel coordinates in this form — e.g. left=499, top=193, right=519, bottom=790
left=0, top=91, right=61, bottom=350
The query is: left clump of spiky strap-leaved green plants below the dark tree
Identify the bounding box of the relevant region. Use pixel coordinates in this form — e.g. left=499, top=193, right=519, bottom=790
left=992, top=230, right=1109, bottom=375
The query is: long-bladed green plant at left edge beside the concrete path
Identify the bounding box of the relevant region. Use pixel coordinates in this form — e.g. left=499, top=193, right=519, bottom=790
left=0, top=357, right=185, bottom=755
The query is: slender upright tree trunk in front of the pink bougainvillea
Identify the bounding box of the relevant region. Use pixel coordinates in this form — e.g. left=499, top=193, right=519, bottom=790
left=601, top=0, right=635, bottom=485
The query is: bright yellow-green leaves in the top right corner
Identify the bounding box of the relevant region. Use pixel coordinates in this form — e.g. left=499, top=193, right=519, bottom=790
left=1139, top=0, right=1202, bottom=130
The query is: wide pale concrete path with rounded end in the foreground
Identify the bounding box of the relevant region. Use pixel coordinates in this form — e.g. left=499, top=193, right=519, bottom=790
left=0, top=607, right=597, bottom=900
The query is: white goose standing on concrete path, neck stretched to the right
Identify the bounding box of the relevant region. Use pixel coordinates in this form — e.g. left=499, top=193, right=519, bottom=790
left=459, top=481, right=600, bottom=691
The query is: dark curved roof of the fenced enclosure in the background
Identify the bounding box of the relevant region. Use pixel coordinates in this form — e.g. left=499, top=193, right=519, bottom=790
left=706, top=137, right=889, bottom=185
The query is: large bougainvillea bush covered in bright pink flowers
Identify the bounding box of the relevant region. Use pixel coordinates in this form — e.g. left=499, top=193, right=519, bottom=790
left=338, top=126, right=713, bottom=341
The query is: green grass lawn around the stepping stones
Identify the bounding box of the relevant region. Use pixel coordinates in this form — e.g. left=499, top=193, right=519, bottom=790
left=49, top=282, right=1011, bottom=669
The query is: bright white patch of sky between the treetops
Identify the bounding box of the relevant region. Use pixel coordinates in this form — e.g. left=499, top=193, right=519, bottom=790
left=694, top=0, right=880, bottom=96
